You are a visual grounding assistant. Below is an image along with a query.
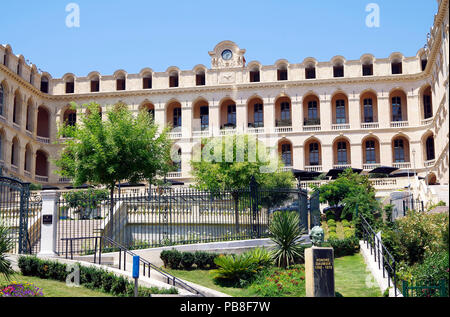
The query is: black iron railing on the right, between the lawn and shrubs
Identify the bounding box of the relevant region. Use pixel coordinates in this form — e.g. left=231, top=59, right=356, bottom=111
left=360, top=215, right=397, bottom=297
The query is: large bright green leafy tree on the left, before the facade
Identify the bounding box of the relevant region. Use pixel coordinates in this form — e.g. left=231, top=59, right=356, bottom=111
left=55, top=103, right=173, bottom=217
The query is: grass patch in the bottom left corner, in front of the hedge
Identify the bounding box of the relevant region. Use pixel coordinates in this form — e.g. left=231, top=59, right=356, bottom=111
left=0, top=273, right=112, bottom=297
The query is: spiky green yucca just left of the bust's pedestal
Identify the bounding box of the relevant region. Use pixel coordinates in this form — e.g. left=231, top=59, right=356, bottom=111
left=269, top=211, right=305, bottom=268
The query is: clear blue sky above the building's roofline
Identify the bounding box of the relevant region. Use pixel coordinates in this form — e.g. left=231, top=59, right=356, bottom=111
left=0, top=0, right=437, bottom=77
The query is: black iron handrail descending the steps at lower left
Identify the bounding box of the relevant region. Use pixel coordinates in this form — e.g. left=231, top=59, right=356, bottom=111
left=62, top=236, right=205, bottom=297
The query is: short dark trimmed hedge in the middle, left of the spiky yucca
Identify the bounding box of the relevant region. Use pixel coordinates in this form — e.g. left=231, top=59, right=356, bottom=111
left=160, top=249, right=219, bottom=270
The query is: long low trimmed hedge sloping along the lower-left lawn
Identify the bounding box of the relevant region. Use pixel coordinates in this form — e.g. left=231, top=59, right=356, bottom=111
left=18, top=256, right=178, bottom=297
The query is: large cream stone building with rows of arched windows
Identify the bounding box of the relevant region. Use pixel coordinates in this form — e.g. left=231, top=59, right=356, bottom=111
left=0, top=0, right=449, bottom=196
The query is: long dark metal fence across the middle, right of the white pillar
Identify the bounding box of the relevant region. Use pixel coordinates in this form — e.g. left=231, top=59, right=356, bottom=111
left=57, top=184, right=308, bottom=255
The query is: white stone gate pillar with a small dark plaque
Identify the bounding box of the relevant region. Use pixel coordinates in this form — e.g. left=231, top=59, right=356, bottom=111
left=38, top=191, right=59, bottom=257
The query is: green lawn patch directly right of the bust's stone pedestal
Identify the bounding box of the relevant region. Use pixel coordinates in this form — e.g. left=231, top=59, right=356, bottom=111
left=334, top=254, right=381, bottom=297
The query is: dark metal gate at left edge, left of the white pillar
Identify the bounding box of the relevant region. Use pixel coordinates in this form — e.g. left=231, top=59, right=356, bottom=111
left=0, top=175, right=41, bottom=254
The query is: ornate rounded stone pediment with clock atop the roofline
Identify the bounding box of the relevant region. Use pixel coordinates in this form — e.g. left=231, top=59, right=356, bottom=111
left=209, top=41, right=245, bottom=69
